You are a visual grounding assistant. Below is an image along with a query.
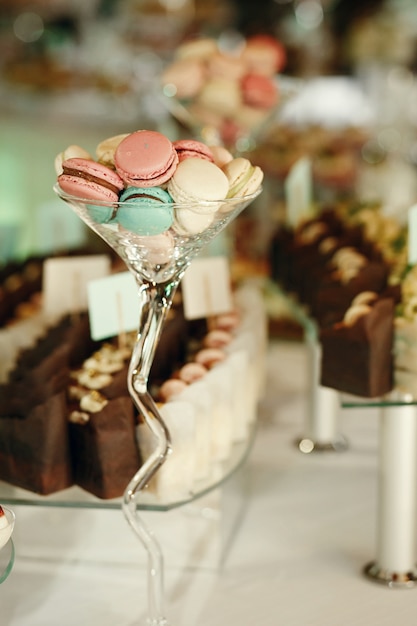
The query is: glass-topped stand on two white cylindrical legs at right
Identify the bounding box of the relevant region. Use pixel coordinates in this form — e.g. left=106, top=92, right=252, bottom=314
left=270, top=285, right=417, bottom=588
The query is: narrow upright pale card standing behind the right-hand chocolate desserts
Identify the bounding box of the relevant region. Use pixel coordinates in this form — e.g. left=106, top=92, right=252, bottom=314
left=284, top=157, right=313, bottom=228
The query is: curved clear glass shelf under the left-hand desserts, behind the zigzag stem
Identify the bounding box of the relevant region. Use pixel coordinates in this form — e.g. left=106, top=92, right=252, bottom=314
left=0, top=424, right=256, bottom=510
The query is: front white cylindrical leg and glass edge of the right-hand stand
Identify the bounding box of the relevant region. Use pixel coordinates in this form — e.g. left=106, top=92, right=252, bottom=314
left=342, top=392, right=417, bottom=588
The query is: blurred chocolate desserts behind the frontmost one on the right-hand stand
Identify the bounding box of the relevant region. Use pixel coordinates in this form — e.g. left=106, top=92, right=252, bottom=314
left=271, top=204, right=400, bottom=326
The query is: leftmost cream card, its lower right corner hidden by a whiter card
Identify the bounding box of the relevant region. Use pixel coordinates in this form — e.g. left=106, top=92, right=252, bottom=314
left=42, top=254, right=111, bottom=317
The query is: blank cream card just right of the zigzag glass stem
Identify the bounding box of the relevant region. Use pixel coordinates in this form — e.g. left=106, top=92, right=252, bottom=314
left=181, top=256, right=233, bottom=320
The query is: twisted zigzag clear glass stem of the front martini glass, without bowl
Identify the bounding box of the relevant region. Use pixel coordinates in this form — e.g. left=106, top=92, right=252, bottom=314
left=122, top=276, right=180, bottom=626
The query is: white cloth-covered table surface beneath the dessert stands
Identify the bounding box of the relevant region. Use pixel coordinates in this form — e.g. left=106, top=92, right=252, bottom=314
left=0, top=342, right=416, bottom=626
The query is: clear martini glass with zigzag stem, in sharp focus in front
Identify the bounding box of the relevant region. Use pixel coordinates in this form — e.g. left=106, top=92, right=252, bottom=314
left=54, top=179, right=261, bottom=626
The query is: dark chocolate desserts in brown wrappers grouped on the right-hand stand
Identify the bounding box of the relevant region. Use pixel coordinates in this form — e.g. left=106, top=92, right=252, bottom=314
left=270, top=203, right=406, bottom=397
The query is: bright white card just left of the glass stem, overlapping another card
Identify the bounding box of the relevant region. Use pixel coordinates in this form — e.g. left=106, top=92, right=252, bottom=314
left=88, top=272, right=139, bottom=341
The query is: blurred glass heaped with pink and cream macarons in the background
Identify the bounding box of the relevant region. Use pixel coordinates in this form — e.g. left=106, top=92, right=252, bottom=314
left=159, top=33, right=296, bottom=155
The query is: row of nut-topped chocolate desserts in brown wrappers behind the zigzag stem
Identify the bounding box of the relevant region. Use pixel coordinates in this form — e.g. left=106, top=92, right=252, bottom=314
left=67, top=294, right=191, bottom=499
